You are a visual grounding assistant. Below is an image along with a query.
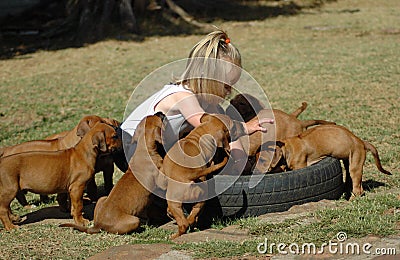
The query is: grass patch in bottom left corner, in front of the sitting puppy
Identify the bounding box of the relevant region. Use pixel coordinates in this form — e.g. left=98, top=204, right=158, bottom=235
left=0, top=224, right=171, bottom=259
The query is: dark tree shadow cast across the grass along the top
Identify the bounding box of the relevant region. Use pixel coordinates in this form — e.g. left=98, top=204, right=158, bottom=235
left=0, top=0, right=332, bottom=59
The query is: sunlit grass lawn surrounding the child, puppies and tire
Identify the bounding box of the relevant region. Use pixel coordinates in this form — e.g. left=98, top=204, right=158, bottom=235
left=0, top=0, right=400, bottom=259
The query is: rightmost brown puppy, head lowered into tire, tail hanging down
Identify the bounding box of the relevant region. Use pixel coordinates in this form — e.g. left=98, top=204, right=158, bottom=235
left=274, top=125, right=391, bottom=197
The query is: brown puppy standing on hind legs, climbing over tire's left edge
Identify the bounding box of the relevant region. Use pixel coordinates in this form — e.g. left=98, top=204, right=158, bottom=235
left=163, top=114, right=244, bottom=239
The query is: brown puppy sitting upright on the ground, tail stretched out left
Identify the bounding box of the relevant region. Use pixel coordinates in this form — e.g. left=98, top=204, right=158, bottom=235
left=60, top=113, right=165, bottom=234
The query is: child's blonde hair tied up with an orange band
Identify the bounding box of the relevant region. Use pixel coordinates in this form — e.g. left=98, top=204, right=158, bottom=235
left=179, top=29, right=242, bottom=103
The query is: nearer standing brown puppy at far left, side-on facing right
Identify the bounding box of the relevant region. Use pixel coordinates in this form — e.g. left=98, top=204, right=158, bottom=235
left=0, top=123, right=122, bottom=230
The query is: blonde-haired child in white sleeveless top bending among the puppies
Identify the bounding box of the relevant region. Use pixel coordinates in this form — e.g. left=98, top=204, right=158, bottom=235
left=121, top=29, right=273, bottom=173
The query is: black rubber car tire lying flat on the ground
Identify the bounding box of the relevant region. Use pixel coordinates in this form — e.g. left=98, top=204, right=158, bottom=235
left=199, top=157, right=344, bottom=223
